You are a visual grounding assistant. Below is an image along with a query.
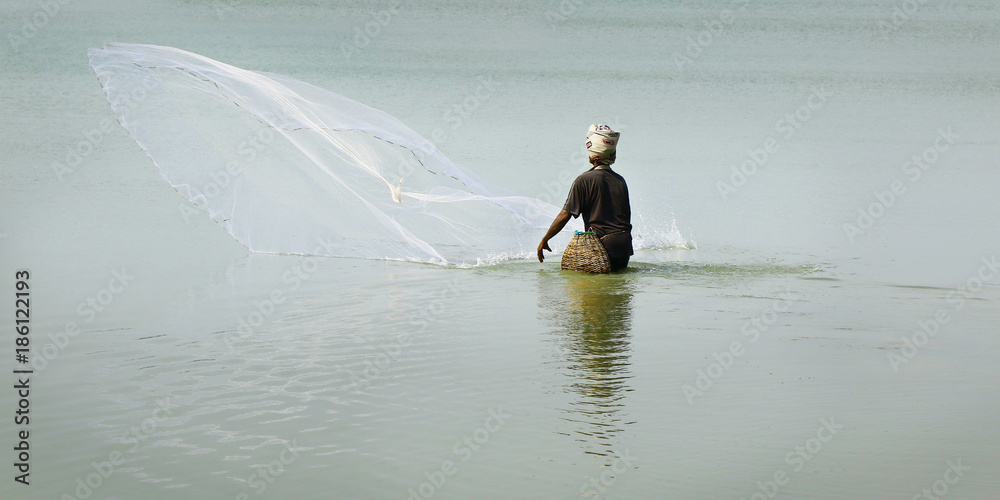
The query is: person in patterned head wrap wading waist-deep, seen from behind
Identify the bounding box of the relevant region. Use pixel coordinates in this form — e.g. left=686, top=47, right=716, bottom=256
left=538, top=124, right=633, bottom=271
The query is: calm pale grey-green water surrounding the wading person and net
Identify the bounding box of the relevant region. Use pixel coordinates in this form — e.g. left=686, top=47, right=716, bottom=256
left=0, top=0, right=1000, bottom=500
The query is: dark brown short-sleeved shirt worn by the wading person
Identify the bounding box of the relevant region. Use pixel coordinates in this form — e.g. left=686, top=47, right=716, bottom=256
left=563, top=168, right=633, bottom=258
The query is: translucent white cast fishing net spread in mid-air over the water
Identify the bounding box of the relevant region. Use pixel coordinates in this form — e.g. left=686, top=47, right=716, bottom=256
left=89, top=44, right=579, bottom=263
